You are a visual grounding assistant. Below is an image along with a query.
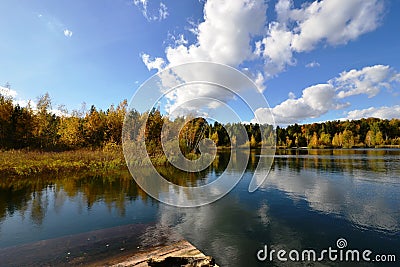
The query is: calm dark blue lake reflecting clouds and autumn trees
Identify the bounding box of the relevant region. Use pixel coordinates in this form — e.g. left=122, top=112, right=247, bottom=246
left=0, top=149, right=400, bottom=266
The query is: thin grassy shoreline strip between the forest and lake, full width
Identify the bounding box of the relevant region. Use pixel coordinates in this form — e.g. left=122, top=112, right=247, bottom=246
left=0, top=145, right=400, bottom=178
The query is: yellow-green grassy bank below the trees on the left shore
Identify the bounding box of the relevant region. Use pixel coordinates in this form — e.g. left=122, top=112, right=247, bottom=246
left=0, top=149, right=126, bottom=176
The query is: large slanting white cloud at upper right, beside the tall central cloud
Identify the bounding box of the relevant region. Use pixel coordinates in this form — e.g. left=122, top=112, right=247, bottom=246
left=254, top=0, right=383, bottom=78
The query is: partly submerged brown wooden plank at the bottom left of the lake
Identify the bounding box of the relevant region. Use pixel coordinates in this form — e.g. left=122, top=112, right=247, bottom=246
left=0, top=224, right=216, bottom=267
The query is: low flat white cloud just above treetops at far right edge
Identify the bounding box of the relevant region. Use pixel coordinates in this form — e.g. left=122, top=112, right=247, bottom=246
left=345, top=105, right=400, bottom=120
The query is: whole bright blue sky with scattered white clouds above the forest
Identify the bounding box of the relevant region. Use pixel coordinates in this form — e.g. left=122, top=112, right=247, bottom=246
left=0, top=0, right=400, bottom=124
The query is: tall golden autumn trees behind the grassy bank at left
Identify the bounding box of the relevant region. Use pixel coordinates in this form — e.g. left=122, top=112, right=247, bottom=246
left=0, top=93, right=127, bottom=150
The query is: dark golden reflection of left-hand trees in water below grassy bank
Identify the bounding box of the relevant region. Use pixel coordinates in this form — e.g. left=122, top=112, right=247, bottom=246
left=0, top=171, right=148, bottom=225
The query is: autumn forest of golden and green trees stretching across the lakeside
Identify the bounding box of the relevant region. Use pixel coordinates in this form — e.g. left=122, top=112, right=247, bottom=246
left=0, top=93, right=400, bottom=153
